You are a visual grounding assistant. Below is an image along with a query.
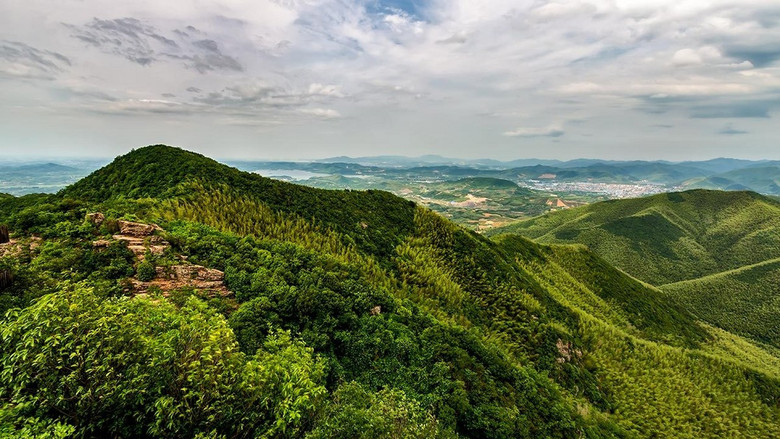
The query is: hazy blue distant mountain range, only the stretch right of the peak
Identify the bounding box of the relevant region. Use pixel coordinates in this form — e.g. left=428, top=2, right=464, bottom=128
left=235, top=156, right=780, bottom=195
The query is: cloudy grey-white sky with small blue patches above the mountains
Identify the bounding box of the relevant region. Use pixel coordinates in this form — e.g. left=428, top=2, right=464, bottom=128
left=0, top=0, right=780, bottom=160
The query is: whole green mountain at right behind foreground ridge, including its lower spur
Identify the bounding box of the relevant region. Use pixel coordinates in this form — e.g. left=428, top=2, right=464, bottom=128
left=494, top=190, right=780, bottom=347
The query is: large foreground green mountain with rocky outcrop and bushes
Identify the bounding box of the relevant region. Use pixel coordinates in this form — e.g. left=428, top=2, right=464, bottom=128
left=0, top=145, right=780, bottom=438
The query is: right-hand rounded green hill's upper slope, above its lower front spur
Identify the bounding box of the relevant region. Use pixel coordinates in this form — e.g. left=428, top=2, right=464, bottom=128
left=491, top=190, right=780, bottom=285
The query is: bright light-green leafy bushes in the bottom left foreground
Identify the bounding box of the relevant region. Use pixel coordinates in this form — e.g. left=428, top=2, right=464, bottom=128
left=0, top=288, right=324, bottom=437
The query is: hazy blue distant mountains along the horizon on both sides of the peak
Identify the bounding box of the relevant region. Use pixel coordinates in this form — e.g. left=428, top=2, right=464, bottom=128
left=0, top=155, right=780, bottom=195
